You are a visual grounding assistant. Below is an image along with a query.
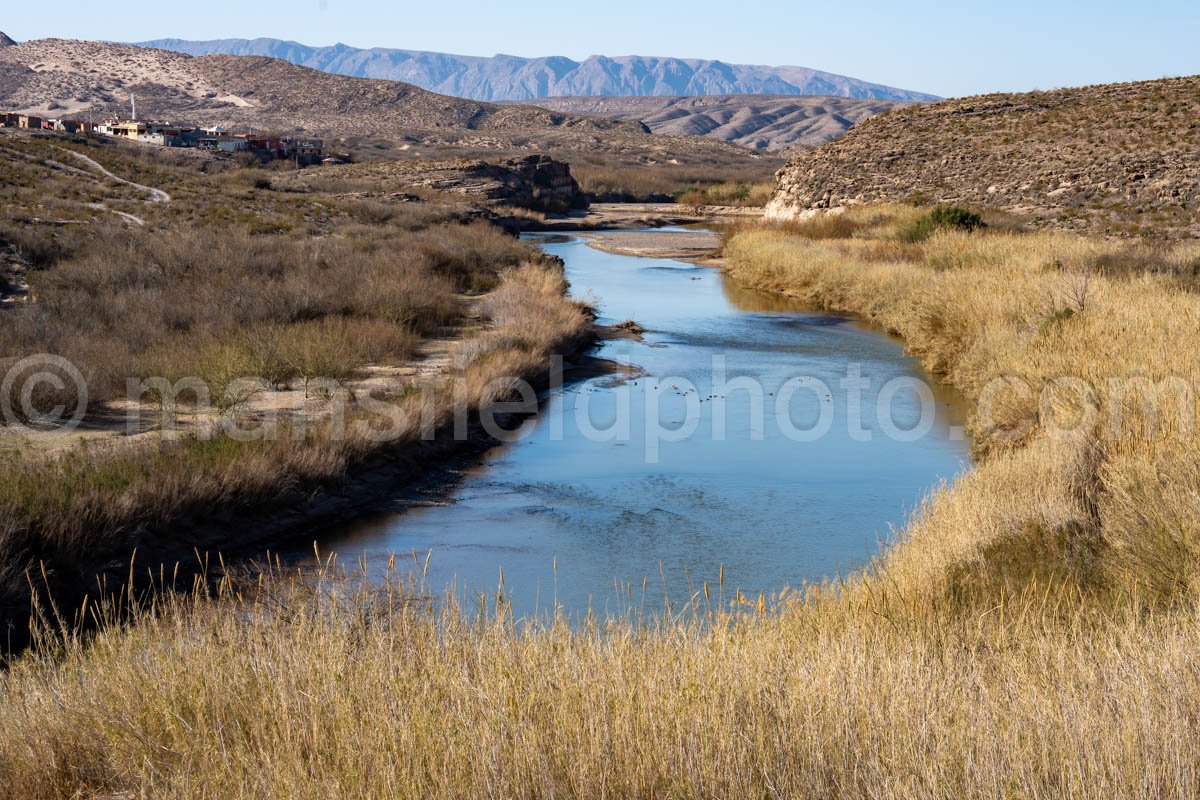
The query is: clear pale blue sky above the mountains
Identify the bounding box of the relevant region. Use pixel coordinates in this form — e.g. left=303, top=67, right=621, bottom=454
left=0, top=0, right=1200, bottom=96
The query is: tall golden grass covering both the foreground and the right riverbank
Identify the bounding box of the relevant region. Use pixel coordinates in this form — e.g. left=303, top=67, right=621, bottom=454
left=0, top=207, right=1200, bottom=798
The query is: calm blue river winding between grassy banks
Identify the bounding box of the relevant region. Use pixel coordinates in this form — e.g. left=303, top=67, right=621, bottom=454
left=309, top=231, right=970, bottom=615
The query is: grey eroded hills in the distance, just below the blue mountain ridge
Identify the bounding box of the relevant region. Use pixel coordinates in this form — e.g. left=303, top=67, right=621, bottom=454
left=520, top=95, right=905, bottom=150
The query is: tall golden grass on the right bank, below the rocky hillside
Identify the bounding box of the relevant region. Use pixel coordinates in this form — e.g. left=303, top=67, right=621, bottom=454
left=726, top=207, right=1200, bottom=599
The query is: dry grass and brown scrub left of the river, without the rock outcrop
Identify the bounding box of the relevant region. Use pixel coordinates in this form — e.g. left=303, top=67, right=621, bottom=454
left=0, top=131, right=590, bottom=648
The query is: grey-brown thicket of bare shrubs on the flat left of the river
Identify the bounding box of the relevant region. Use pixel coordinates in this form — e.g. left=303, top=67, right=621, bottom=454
left=0, top=217, right=532, bottom=403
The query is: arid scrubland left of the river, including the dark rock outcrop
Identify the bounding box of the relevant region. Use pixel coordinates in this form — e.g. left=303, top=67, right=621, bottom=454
left=0, top=130, right=593, bottom=644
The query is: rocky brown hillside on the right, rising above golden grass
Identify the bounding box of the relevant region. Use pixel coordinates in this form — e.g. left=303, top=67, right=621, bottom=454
left=768, top=77, right=1200, bottom=236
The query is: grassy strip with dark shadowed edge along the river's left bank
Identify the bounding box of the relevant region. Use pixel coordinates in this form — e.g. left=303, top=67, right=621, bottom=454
left=0, top=264, right=596, bottom=649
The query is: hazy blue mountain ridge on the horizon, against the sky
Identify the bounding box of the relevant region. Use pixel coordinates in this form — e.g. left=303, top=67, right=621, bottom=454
left=139, top=38, right=938, bottom=102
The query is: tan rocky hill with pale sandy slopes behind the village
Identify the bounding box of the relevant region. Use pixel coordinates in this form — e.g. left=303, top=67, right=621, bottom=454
left=0, top=38, right=640, bottom=133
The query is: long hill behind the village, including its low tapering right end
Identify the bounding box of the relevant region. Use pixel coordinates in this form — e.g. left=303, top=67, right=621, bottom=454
left=0, top=40, right=777, bottom=170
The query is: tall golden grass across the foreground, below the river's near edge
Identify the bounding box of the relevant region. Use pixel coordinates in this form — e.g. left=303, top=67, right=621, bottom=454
left=0, top=563, right=1200, bottom=799
